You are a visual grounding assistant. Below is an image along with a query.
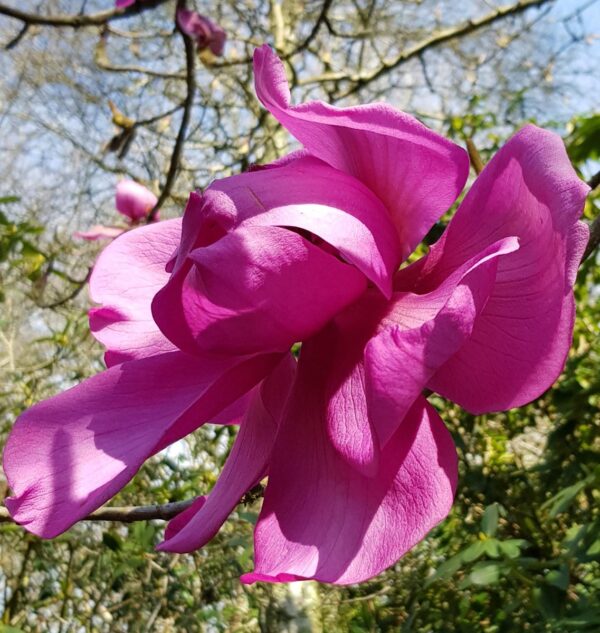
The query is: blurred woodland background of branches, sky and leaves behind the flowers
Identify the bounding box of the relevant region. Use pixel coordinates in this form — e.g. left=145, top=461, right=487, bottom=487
left=0, top=0, right=600, bottom=633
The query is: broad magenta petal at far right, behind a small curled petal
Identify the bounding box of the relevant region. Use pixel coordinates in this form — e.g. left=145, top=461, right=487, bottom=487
left=423, top=126, right=588, bottom=413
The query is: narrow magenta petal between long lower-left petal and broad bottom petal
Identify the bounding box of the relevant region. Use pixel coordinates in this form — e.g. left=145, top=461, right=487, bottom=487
left=158, top=356, right=296, bottom=552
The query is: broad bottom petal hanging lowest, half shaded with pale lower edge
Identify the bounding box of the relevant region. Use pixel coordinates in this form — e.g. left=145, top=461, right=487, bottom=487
left=242, top=396, right=457, bottom=584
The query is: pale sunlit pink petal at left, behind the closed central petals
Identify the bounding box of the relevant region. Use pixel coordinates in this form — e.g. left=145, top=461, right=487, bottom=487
left=90, top=219, right=181, bottom=366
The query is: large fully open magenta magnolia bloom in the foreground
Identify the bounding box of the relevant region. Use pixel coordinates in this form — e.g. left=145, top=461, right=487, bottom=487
left=4, top=47, right=587, bottom=584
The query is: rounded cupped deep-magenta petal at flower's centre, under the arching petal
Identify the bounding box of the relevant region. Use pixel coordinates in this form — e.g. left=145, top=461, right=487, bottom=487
left=153, top=226, right=366, bottom=355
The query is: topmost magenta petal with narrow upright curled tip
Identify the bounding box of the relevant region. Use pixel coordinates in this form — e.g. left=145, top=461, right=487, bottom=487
left=254, top=45, right=469, bottom=259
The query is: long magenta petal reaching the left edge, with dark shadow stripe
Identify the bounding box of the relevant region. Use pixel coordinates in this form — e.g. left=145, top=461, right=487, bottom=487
left=4, top=352, right=280, bottom=538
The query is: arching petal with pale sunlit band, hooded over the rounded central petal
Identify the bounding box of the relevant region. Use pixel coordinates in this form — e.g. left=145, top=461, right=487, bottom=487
left=205, top=154, right=401, bottom=296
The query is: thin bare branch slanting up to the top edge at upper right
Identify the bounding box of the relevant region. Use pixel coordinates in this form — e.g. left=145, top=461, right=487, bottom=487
left=336, top=0, right=553, bottom=101
